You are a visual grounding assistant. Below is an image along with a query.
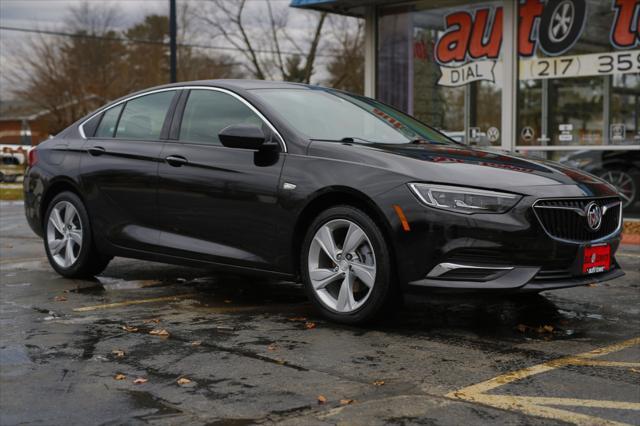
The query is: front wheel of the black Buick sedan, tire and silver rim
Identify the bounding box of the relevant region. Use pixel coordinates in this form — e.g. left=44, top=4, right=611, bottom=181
left=302, top=206, right=392, bottom=324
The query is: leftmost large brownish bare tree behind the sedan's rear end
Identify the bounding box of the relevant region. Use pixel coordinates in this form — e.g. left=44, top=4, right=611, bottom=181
left=8, top=3, right=125, bottom=133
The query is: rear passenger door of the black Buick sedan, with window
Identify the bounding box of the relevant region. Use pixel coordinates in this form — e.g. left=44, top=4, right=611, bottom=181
left=80, top=90, right=177, bottom=249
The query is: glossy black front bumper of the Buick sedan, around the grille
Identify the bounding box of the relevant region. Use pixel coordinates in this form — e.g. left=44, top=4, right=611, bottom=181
left=384, top=185, right=623, bottom=291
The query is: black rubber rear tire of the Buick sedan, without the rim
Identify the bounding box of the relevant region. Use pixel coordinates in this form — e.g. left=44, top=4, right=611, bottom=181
left=43, top=191, right=112, bottom=278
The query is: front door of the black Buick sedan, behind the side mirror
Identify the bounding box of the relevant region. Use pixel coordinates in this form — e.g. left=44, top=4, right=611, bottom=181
left=158, top=88, right=284, bottom=269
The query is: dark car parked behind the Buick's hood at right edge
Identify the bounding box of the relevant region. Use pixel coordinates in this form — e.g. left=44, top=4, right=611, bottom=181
left=560, top=150, right=640, bottom=209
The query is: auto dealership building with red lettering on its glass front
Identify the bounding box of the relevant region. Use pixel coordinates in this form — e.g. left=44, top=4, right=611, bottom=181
left=291, top=0, right=640, bottom=213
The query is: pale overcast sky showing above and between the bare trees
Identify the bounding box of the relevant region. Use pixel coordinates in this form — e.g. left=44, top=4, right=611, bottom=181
left=0, top=0, right=336, bottom=99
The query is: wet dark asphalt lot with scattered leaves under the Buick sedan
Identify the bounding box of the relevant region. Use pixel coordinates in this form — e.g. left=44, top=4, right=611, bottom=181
left=0, top=202, right=640, bottom=425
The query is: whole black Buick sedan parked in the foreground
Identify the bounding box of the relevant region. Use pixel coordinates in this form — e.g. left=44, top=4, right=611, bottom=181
left=24, top=81, right=623, bottom=323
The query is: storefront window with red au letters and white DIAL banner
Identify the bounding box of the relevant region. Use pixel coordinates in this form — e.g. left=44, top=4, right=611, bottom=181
left=377, top=1, right=502, bottom=146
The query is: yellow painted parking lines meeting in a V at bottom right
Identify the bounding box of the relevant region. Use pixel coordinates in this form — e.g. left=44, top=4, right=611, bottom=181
left=446, top=337, right=640, bottom=425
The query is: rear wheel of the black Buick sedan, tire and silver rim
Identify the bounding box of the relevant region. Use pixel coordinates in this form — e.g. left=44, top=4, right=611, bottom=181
left=44, top=192, right=111, bottom=278
